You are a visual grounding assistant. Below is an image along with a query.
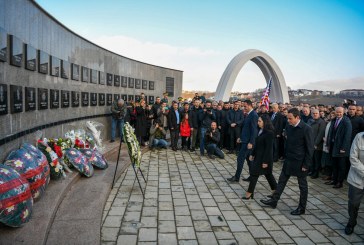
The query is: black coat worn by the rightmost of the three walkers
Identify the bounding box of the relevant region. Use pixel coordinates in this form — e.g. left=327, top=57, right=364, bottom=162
left=282, top=120, right=314, bottom=177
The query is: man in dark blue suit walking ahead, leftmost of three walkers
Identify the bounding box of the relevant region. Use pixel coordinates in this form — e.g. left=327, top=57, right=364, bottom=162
left=228, top=100, right=258, bottom=182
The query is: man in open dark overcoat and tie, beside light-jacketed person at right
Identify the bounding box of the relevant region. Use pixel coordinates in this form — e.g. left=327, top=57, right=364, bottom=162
left=325, top=107, right=352, bottom=188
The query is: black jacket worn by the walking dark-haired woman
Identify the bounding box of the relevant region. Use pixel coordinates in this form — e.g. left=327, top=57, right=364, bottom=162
left=249, top=130, right=274, bottom=175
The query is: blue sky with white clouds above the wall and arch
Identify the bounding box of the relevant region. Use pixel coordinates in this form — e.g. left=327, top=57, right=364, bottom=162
left=37, top=0, right=364, bottom=91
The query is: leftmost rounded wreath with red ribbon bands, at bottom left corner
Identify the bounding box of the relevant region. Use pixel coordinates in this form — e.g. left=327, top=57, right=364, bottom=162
left=0, top=164, right=33, bottom=227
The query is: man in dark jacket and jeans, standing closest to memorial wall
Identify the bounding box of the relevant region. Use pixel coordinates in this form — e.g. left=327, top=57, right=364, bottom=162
left=110, top=99, right=127, bottom=142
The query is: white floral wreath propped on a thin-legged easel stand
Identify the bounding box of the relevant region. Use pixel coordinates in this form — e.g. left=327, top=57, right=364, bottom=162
left=123, top=122, right=142, bottom=168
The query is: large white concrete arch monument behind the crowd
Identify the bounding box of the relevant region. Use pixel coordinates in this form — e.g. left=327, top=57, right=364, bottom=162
left=215, top=49, right=289, bottom=103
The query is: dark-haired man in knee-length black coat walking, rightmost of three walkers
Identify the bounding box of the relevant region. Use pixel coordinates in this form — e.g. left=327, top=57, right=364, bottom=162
left=260, top=108, right=314, bottom=215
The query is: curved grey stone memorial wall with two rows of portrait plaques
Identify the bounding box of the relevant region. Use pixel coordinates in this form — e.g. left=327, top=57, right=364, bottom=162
left=0, top=0, right=183, bottom=161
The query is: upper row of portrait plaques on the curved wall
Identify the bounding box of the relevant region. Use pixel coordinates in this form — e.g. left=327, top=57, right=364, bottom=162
left=0, top=27, right=154, bottom=90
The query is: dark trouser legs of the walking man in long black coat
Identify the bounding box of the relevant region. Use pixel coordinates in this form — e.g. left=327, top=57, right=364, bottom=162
left=273, top=171, right=308, bottom=209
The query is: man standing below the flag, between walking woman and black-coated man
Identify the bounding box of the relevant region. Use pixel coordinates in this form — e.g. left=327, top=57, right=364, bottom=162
left=270, top=103, right=284, bottom=162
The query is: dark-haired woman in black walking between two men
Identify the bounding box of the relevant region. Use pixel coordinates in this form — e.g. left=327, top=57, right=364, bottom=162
left=242, top=115, right=277, bottom=200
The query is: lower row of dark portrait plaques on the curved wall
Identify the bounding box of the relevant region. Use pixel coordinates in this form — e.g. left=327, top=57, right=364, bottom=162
left=0, top=84, right=154, bottom=115
